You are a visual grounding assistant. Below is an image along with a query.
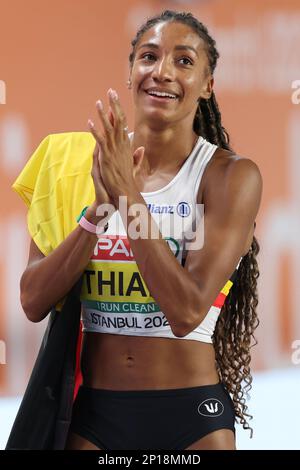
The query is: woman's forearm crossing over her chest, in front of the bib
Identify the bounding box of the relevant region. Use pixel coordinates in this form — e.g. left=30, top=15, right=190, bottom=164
left=121, top=192, right=199, bottom=335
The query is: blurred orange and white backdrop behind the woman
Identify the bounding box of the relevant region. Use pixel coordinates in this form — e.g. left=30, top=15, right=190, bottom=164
left=0, top=0, right=300, bottom=395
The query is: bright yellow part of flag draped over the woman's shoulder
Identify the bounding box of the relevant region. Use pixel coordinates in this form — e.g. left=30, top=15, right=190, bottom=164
left=12, top=132, right=95, bottom=310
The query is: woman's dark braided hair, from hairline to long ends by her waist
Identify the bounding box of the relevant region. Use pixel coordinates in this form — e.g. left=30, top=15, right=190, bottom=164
left=129, top=10, right=259, bottom=437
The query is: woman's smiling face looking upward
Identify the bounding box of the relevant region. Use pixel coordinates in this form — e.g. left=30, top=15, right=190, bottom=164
left=130, top=22, right=213, bottom=128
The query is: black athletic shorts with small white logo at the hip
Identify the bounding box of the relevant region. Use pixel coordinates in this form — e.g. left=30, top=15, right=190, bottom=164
left=71, top=383, right=235, bottom=450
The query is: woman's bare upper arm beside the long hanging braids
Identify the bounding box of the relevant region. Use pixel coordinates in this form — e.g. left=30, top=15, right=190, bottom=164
left=184, top=158, right=262, bottom=313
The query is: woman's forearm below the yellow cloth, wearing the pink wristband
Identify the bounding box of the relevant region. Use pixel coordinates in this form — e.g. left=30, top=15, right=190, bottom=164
left=20, top=205, right=113, bottom=322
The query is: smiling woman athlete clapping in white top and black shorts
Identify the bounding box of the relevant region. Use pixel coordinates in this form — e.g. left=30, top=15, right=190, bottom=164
left=21, top=11, right=262, bottom=450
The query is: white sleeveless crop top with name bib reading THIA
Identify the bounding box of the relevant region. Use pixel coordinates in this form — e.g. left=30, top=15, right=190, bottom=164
left=80, top=137, right=236, bottom=343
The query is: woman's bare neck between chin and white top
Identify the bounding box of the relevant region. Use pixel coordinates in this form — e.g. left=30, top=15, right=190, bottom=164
left=131, top=124, right=198, bottom=175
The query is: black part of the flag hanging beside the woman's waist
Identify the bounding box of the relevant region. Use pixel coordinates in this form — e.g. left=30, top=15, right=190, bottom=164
left=6, top=276, right=82, bottom=450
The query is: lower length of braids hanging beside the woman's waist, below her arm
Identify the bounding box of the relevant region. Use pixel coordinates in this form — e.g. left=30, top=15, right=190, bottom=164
left=213, top=237, right=259, bottom=437
